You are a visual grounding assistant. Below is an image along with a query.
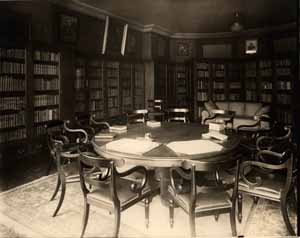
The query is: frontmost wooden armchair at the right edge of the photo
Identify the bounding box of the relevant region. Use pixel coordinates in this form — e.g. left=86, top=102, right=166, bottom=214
left=238, top=140, right=297, bottom=236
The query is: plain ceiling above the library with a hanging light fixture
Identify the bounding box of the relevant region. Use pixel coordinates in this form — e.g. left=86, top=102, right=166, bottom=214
left=74, top=0, right=297, bottom=33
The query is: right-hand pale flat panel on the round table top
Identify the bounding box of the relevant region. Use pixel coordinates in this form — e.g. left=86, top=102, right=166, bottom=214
left=167, top=140, right=223, bottom=155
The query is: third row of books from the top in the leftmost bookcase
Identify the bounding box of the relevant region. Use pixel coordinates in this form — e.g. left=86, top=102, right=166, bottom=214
left=0, top=75, right=26, bottom=92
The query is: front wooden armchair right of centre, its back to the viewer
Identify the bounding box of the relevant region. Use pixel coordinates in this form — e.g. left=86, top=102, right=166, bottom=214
left=168, top=155, right=239, bottom=237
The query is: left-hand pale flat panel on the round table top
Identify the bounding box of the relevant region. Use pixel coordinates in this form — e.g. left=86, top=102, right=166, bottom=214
left=105, top=138, right=160, bottom=155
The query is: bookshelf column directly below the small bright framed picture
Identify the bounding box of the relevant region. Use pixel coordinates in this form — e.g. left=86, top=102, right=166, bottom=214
left=243, top=60, right=259, bottom=102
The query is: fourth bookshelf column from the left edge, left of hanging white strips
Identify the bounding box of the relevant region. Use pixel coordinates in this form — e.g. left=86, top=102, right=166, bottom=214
left=87, top=59, right=105, bottom=119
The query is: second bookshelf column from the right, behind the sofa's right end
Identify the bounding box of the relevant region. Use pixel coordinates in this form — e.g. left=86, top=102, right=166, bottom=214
left=258, top=59, right=273, bottom=104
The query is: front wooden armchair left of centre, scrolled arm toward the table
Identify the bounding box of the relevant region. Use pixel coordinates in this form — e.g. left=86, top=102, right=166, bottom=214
left=79, top=152, right=158, bottom=237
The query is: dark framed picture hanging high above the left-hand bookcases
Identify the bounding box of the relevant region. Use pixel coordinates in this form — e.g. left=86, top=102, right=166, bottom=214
left=59, top=14, right=79, bottom=44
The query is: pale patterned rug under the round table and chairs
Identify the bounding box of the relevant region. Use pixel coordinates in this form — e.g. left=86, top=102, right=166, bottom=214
left=0, top=175, right=296, bottom=238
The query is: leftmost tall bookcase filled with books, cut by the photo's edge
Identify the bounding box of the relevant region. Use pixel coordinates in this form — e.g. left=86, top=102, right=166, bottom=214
left=0, top=48, right=27, bottom=143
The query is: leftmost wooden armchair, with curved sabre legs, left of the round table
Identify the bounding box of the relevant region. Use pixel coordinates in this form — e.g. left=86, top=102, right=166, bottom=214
left=47, top=121, right=88, bottom=217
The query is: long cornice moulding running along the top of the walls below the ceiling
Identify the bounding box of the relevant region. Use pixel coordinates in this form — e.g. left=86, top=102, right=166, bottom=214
left=50, top=0, right=297, bottom=39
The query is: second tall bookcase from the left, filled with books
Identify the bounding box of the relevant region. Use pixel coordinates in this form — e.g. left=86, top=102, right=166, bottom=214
left=33, top=49, right=60, bottom=136
